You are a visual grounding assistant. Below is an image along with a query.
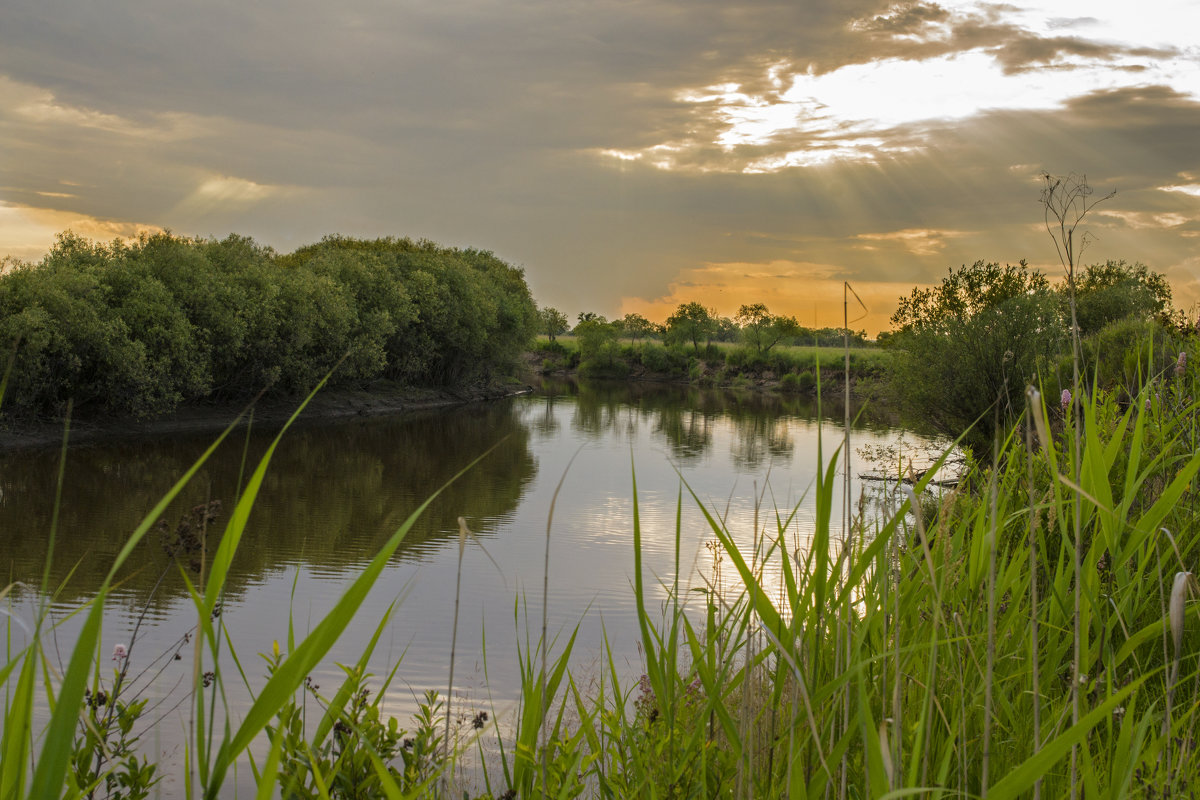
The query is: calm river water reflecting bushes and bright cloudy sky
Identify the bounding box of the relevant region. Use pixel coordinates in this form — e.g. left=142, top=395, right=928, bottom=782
left=0, top=384, right=929, bottom=796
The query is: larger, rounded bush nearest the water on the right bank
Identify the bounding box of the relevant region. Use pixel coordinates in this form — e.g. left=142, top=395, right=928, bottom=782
left=892, top=261, right=1064, bottom=447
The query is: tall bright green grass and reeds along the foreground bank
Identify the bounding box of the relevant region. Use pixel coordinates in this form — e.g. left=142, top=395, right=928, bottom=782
left=0, top=357, right=1200, bottom=800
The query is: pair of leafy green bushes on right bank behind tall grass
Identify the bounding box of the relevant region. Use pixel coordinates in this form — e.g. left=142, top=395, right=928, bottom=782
left=881, top=261, right=1195, bottom=447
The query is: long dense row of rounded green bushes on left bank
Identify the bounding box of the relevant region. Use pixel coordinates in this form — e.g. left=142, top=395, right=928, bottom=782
left=0, top=233, right=538, bottom=416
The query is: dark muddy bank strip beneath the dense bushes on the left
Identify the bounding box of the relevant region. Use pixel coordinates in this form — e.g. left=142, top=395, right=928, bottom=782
left=0, top=381, right=533, bottom=452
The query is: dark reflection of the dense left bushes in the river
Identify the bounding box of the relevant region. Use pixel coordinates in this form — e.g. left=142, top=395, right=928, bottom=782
left=0, top=402, right=536, bottom=604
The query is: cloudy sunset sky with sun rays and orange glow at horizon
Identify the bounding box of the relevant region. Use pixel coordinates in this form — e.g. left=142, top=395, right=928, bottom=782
left=0, top=0, right=1200, bottom=335
